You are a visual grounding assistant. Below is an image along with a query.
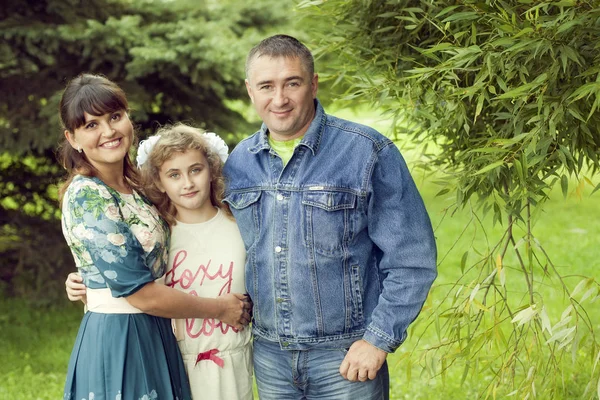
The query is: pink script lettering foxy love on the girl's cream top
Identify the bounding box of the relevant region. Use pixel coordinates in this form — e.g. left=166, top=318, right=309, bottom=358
left=165, top=250, right=238, bottom=338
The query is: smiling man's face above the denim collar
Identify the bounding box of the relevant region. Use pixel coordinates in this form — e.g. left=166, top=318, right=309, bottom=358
left=246, top=56, right=319, bottom=141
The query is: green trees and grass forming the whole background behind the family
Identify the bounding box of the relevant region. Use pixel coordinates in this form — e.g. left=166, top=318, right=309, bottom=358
left=0, top=0, right=600, bottom=399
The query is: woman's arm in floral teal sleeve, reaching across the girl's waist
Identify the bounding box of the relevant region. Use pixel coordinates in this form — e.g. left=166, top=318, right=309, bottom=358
left=63, top=179, right=251, bottom=328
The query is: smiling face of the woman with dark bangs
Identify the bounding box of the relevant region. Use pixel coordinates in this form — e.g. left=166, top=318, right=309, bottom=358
left=65, top=110, right=133, bottom=173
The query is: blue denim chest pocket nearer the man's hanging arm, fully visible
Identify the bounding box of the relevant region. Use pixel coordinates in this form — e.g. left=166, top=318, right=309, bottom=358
left=302, top=190, right=356, bottom=256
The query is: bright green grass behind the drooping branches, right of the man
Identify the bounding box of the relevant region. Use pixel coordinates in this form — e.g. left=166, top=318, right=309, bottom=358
left=389, top=181, right=600, bottom=399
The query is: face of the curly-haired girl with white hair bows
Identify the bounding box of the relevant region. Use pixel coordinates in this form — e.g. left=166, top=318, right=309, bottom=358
left=157, top=150, right=217, bottom=223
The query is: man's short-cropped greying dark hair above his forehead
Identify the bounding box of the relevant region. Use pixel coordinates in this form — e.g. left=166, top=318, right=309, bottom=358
left=246, top=35, right=315, bottom=79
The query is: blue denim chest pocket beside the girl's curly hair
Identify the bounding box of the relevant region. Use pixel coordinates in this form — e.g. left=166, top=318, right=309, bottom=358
left=223, top=190, right=261, bottom=250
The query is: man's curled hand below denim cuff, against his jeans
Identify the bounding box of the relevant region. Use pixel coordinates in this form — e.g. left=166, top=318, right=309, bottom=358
left=340, top=339, right=387, bottom=382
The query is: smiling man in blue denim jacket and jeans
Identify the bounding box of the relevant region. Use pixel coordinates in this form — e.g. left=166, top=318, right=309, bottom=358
left=225, top=35, right=436, bottom=399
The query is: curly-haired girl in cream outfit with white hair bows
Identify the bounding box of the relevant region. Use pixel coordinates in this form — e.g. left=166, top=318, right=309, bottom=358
left=138, top=124, right=252, bottom=400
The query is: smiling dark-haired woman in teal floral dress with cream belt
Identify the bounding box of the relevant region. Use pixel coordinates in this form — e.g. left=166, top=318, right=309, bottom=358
left=59, top=74, right=251, bottom=400
